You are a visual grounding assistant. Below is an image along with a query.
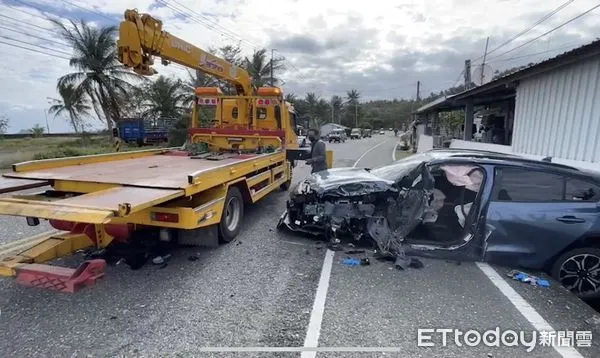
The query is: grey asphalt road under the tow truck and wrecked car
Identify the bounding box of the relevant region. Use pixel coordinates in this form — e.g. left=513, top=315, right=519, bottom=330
left=0, top=134, right=600, bottom=357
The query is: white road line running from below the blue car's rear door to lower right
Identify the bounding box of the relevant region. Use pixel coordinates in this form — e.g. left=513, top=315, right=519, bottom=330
left=476, top=262, right=583, bottom=358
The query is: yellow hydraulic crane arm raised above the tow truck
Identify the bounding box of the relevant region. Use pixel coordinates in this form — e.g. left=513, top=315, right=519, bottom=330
left=117, top=10, right=254, bottom=96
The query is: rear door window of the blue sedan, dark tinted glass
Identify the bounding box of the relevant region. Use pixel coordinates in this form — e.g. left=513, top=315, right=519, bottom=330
left=492, top=168, right=564, bottom=202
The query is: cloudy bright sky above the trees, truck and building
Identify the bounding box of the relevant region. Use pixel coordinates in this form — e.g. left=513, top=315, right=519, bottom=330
left=0, top=0, right=600, bottom=133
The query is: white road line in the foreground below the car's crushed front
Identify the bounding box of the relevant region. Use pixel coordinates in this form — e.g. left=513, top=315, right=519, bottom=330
left=301, top=250, right=335, bottom=358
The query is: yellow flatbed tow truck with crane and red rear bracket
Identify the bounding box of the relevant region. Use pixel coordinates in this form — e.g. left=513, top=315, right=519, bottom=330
left=0, top=10, right=332, bottom=292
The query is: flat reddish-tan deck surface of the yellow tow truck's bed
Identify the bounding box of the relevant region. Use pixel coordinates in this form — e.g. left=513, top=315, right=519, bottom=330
left=4, top=154, right=257, bottom=189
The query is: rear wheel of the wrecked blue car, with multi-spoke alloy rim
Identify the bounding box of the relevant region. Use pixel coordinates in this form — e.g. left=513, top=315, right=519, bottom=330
left=550, top=247, right=600, bottom=299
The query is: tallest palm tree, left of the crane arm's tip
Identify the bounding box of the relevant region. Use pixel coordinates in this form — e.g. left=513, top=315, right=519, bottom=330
left=51, top=19, right=143, bottom=138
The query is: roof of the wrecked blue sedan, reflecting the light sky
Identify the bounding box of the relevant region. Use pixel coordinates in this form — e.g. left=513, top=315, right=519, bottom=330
left=422, top=148, right=600, bottom=182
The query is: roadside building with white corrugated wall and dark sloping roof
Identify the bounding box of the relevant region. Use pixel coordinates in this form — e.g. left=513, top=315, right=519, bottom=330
left=415, top=40, right=600, bottom=169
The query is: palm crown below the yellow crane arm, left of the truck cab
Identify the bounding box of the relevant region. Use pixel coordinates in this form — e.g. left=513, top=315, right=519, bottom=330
left=142, top=76, right=188, bottom=120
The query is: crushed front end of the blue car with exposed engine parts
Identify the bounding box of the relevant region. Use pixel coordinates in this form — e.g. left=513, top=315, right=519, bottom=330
left=279, top=162, right=433, bottom=255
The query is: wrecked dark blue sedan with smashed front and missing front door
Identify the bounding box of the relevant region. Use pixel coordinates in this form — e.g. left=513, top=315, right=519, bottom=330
left=279, top=149, right=600, bottom=298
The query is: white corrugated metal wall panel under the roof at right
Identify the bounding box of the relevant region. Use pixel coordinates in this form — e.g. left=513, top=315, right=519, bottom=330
left=512, top=57, right=600, bottom=162
